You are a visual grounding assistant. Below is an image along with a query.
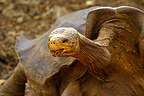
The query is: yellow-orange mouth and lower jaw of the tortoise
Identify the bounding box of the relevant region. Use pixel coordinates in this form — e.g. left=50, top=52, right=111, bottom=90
left=50, top=48, right=73, bottom=56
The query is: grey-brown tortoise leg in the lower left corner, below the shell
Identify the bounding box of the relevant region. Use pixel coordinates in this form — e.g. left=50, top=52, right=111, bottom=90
left=0, top=64, right=26, bottom=96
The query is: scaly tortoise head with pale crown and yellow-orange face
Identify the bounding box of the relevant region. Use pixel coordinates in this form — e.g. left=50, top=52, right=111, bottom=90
left=48, top=27, right=79, bottom=56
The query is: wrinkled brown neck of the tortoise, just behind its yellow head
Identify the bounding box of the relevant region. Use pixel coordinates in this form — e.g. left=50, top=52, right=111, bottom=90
left=76, top=34, right=110, bottom=79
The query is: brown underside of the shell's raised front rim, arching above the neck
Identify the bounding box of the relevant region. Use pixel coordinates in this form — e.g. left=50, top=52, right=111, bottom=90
left=85, top=6, right=144, bottom=39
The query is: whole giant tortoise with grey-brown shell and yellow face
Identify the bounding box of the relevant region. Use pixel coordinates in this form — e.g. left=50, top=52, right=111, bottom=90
left=0, top=6, right=144, bottom=96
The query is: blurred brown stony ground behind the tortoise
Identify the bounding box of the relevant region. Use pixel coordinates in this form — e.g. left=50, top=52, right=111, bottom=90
left=0, top=0, right=144, bottom=79
